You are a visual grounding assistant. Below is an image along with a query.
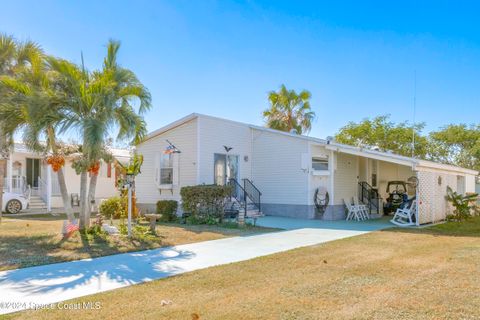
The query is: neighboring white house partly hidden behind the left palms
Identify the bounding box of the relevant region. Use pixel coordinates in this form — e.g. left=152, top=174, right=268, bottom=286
left=4, top=143, right=130, bottom=211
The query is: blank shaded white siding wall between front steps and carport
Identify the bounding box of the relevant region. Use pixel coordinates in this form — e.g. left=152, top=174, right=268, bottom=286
left=252, top=129, right=309, bottom=205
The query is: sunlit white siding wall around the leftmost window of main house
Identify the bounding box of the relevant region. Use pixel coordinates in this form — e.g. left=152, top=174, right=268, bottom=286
left=135, top=119, right=197, bottom=204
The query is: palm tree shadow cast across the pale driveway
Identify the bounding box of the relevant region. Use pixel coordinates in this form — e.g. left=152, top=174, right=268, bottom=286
left=0, top=248, right=195, bottom=300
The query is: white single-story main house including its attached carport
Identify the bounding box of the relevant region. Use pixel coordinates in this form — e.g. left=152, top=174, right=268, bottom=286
left=136, top=114, right=478, bottom=224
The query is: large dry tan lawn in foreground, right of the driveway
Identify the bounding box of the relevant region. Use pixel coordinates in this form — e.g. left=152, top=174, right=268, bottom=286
left=9, top=218, right=480, bottom=319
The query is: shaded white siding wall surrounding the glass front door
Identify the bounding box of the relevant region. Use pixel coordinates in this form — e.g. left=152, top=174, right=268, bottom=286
left=198, top=116, right=252, bottom=184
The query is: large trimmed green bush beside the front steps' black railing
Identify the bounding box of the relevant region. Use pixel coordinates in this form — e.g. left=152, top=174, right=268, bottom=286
left=180, top=185, right=232, bottom=224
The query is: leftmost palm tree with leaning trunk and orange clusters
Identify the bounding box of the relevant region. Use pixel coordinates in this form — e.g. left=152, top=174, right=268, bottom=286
left=0, top=33, right=74, bottom=221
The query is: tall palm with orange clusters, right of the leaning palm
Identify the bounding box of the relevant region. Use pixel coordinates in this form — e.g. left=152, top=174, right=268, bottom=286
left=51, top=41, right=151, bottom=228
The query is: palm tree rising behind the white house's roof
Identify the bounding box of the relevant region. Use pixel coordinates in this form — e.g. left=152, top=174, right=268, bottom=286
left=263, top=85, right=315, bottom=134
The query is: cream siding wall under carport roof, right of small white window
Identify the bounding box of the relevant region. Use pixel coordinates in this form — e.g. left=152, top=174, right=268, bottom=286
left=332, top=152, right=358, bottom=205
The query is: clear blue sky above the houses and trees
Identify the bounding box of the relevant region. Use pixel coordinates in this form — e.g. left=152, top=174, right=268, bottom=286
left=0, top=0, right=480, bottom=137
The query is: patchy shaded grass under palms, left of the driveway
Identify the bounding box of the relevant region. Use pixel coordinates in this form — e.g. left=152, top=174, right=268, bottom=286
left=0, top=215, right=272, bottom=270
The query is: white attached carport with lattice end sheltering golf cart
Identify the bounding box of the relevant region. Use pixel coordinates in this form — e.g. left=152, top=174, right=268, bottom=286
left=326, top=143, right=478, bottom=225
